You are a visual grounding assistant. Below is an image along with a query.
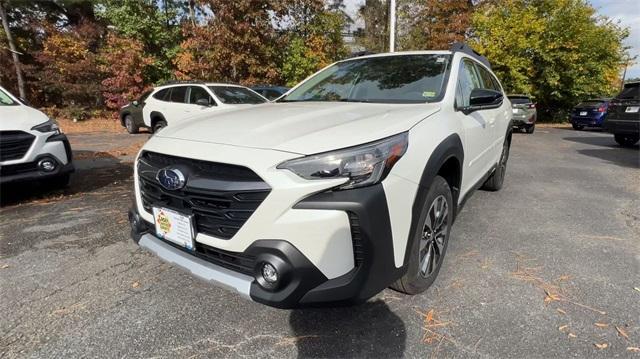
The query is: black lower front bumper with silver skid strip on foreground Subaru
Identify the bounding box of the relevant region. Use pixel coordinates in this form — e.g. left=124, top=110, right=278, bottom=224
left=130, top=184, right=404, bottom=308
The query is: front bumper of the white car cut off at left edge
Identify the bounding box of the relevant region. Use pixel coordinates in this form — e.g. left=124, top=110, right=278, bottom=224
left=0, top=134, right=75, bottom=184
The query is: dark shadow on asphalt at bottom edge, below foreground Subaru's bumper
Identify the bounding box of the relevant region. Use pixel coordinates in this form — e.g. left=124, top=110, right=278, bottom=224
left=289, top=301, right=407, bottom=358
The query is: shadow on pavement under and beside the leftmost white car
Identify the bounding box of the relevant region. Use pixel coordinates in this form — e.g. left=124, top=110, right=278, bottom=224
left=0, top=151, right=133, bottom=207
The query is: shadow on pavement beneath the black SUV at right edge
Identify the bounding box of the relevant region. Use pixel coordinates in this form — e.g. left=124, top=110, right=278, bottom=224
left=564, top=135, right=640, bottom=168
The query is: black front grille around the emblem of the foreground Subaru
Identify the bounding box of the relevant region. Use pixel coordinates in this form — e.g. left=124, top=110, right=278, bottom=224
left=138, top=152, right=271, bottom=239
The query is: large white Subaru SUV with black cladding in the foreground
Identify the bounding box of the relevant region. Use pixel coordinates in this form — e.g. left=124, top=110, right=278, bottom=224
left=129, top=44, right=512, bottom=308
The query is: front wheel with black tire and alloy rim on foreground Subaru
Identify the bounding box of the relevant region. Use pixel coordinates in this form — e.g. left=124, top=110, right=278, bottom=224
left=391, top=176, right=453, bottom=294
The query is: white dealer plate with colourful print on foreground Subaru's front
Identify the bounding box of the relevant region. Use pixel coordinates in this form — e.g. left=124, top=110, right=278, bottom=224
left=153, top=207, right=194, bottom=250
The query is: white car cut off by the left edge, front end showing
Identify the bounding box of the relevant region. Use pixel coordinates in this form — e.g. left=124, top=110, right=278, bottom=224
left=0, top=87, right=74, bottom=187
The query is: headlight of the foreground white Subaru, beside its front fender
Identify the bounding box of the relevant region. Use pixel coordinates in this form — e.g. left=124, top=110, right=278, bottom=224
left=277, top=132, right=409, bottom=189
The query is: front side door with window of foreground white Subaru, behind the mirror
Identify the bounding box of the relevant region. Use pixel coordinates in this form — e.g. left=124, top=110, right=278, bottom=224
left=455, top=58, right=496, bottom=193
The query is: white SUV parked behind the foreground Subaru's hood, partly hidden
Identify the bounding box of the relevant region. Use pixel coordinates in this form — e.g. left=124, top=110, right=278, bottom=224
left=142, top=82, right=269, bottom=132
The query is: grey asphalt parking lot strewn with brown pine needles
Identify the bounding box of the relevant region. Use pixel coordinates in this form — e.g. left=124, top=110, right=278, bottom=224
left=0, top=128, right=640, bottom=358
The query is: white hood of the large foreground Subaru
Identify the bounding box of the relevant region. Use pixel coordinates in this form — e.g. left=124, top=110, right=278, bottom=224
left=157, top=102, right=440, bottom=154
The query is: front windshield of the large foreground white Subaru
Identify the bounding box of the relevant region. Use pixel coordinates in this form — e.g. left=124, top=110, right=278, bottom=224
left=281, top=54, right=451, bottom=103
